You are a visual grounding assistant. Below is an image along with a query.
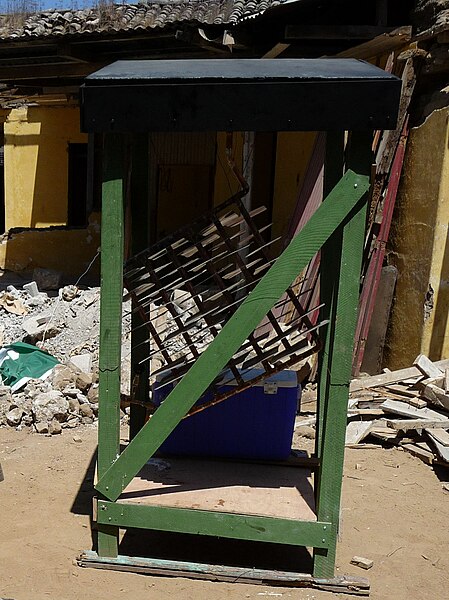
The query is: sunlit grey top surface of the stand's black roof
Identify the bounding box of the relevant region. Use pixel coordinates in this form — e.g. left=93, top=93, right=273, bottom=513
left=86, top=58, right=396, bottom=85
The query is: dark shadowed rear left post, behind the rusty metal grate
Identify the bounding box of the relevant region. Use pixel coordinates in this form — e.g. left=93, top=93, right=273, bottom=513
left=129, top=133, right=150, bottom=439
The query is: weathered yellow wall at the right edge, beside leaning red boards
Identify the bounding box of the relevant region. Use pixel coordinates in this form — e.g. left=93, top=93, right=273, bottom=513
left=385, top=108, right=449, bottom=369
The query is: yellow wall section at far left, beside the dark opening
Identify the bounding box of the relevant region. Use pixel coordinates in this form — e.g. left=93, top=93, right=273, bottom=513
left=4, top=106, right=87, bottom=230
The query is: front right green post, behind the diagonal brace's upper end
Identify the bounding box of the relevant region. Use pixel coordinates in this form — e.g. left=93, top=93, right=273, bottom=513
left=313, top=132, right=372, bottom=577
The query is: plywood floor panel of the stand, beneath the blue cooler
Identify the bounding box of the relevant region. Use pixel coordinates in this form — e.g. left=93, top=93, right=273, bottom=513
left=118, top=458, right=316, bottom=521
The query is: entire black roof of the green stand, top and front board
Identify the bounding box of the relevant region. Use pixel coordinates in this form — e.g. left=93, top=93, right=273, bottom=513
left=81, top=58, right=401, bottom=133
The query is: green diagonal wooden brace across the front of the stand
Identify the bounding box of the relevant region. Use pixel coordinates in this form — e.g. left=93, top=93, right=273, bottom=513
left=95, top=171, right=369, bottom=501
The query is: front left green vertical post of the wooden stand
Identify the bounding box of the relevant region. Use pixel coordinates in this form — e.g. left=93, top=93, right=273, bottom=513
left=98, top=134, right=124, bottom=557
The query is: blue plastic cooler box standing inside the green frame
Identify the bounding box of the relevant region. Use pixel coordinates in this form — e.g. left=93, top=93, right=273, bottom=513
left=153, top=369, right=301, bottom=460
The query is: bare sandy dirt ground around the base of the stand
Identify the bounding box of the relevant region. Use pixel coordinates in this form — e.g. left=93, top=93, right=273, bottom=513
left=0, top=427, right=449, bottom=600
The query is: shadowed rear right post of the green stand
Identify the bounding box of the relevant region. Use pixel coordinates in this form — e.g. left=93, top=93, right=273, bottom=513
left=315, top=131, right=344, bottom=458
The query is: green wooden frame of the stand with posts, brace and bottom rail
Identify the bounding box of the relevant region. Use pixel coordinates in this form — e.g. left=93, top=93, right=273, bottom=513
left=95, top=134, right=370, bottom=578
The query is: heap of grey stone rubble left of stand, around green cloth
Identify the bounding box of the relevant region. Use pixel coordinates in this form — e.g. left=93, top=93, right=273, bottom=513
left=0, top=272, right=131, bottom=434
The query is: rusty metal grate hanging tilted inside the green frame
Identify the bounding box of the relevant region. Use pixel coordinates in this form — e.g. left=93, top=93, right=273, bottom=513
left=124, top=192, right=323, bottom=414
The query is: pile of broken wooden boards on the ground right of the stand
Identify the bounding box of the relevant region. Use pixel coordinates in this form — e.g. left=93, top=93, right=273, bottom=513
left=295, top=354, right=449, bottom=467
